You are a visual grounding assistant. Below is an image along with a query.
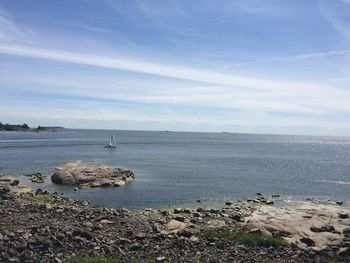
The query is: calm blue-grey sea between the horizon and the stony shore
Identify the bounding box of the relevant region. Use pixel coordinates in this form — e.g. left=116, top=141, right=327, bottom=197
left=0, top=130, right=350, bottom=209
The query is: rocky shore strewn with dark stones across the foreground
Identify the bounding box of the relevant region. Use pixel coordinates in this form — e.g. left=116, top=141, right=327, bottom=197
left=0, top=178, right=350, bottom=263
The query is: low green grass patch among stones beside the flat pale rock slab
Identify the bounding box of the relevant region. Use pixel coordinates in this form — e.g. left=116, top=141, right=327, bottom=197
left=203, top=230, right=288, bottom=249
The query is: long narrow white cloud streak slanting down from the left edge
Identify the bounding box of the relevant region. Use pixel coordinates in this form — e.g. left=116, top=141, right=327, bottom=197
left=0, top=45, right=334, bottom=93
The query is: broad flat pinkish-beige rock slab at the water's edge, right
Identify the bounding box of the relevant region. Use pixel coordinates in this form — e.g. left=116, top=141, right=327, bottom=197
left=246, top=202, right=350, bottom=251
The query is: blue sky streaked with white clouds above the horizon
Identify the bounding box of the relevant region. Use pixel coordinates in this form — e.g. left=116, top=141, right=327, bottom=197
left=0, top=0, right=350, bottom=136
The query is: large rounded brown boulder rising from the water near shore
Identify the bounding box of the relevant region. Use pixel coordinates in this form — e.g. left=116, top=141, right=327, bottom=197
left=51, top=162, right=135, bottom=187
